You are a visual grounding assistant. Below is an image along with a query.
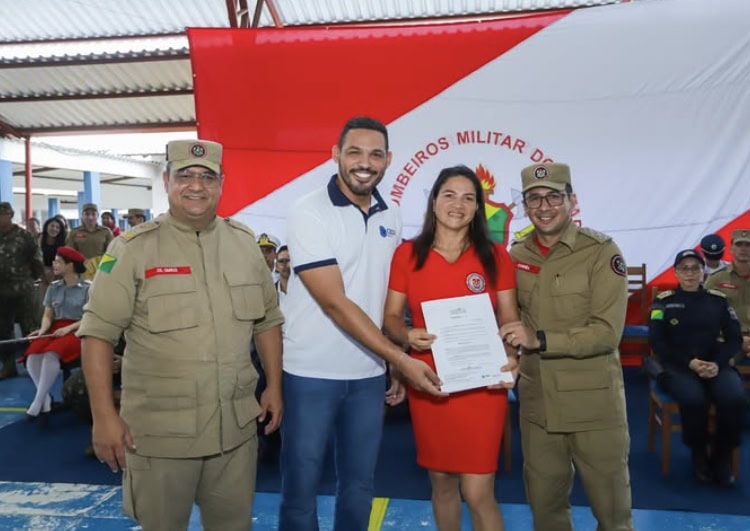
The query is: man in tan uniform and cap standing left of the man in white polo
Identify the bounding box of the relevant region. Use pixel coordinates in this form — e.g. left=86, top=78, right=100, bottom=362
left=78, top=140, right=283, bottom=531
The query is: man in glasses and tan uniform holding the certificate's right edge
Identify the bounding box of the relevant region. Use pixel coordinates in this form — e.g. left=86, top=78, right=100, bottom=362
left=500, top=163, right=633, bottom=531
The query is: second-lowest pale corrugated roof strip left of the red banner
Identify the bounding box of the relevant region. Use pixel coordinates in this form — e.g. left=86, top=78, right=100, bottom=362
left=0, top=59, right=193, bottom=97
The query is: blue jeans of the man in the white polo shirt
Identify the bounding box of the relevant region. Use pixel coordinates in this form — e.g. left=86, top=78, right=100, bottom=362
left=279, top=372, right=385, bottom=531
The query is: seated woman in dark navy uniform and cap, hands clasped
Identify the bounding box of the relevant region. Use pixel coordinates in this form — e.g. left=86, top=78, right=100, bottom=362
left=649, top=249, right=747, bottom=486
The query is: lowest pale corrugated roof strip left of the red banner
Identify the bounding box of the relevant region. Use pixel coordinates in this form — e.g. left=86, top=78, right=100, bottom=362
left=0, top=94, right=195, bottom=132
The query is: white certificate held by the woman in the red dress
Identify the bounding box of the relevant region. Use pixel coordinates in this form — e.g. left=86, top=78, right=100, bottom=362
left=422, top=293, right=513, bottom=393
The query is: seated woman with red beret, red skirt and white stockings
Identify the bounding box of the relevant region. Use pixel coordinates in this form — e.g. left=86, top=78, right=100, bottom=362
left=23, top=246, right=90, bottom=420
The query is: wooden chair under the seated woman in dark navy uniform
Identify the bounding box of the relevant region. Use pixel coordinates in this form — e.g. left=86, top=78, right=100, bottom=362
left=648, top=372, right=740, bottom=480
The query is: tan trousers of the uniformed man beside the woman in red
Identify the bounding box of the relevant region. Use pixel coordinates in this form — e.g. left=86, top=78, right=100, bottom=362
left=521, top=418, right=633, bottom=531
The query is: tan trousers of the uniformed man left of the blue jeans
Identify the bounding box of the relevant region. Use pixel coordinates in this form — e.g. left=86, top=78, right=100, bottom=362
left=122, top=437, right=258, bottom=531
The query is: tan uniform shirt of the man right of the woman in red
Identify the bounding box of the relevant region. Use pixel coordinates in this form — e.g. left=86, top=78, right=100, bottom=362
left=510, top=223, right=627, bottom=432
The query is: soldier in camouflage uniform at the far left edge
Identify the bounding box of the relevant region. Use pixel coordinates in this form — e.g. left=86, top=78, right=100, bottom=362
left=0, top=202, right=44, bottom=379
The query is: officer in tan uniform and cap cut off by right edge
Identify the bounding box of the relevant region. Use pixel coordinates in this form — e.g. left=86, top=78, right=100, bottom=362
left=706, top=229, right=750, bottom=362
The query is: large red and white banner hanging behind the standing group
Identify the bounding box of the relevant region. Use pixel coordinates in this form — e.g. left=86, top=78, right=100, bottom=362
left=188, top=0, right=750, bottom=296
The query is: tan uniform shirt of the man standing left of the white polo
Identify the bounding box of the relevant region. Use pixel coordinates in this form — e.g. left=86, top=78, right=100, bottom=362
left=78, top=214, right=283, bottom=458
